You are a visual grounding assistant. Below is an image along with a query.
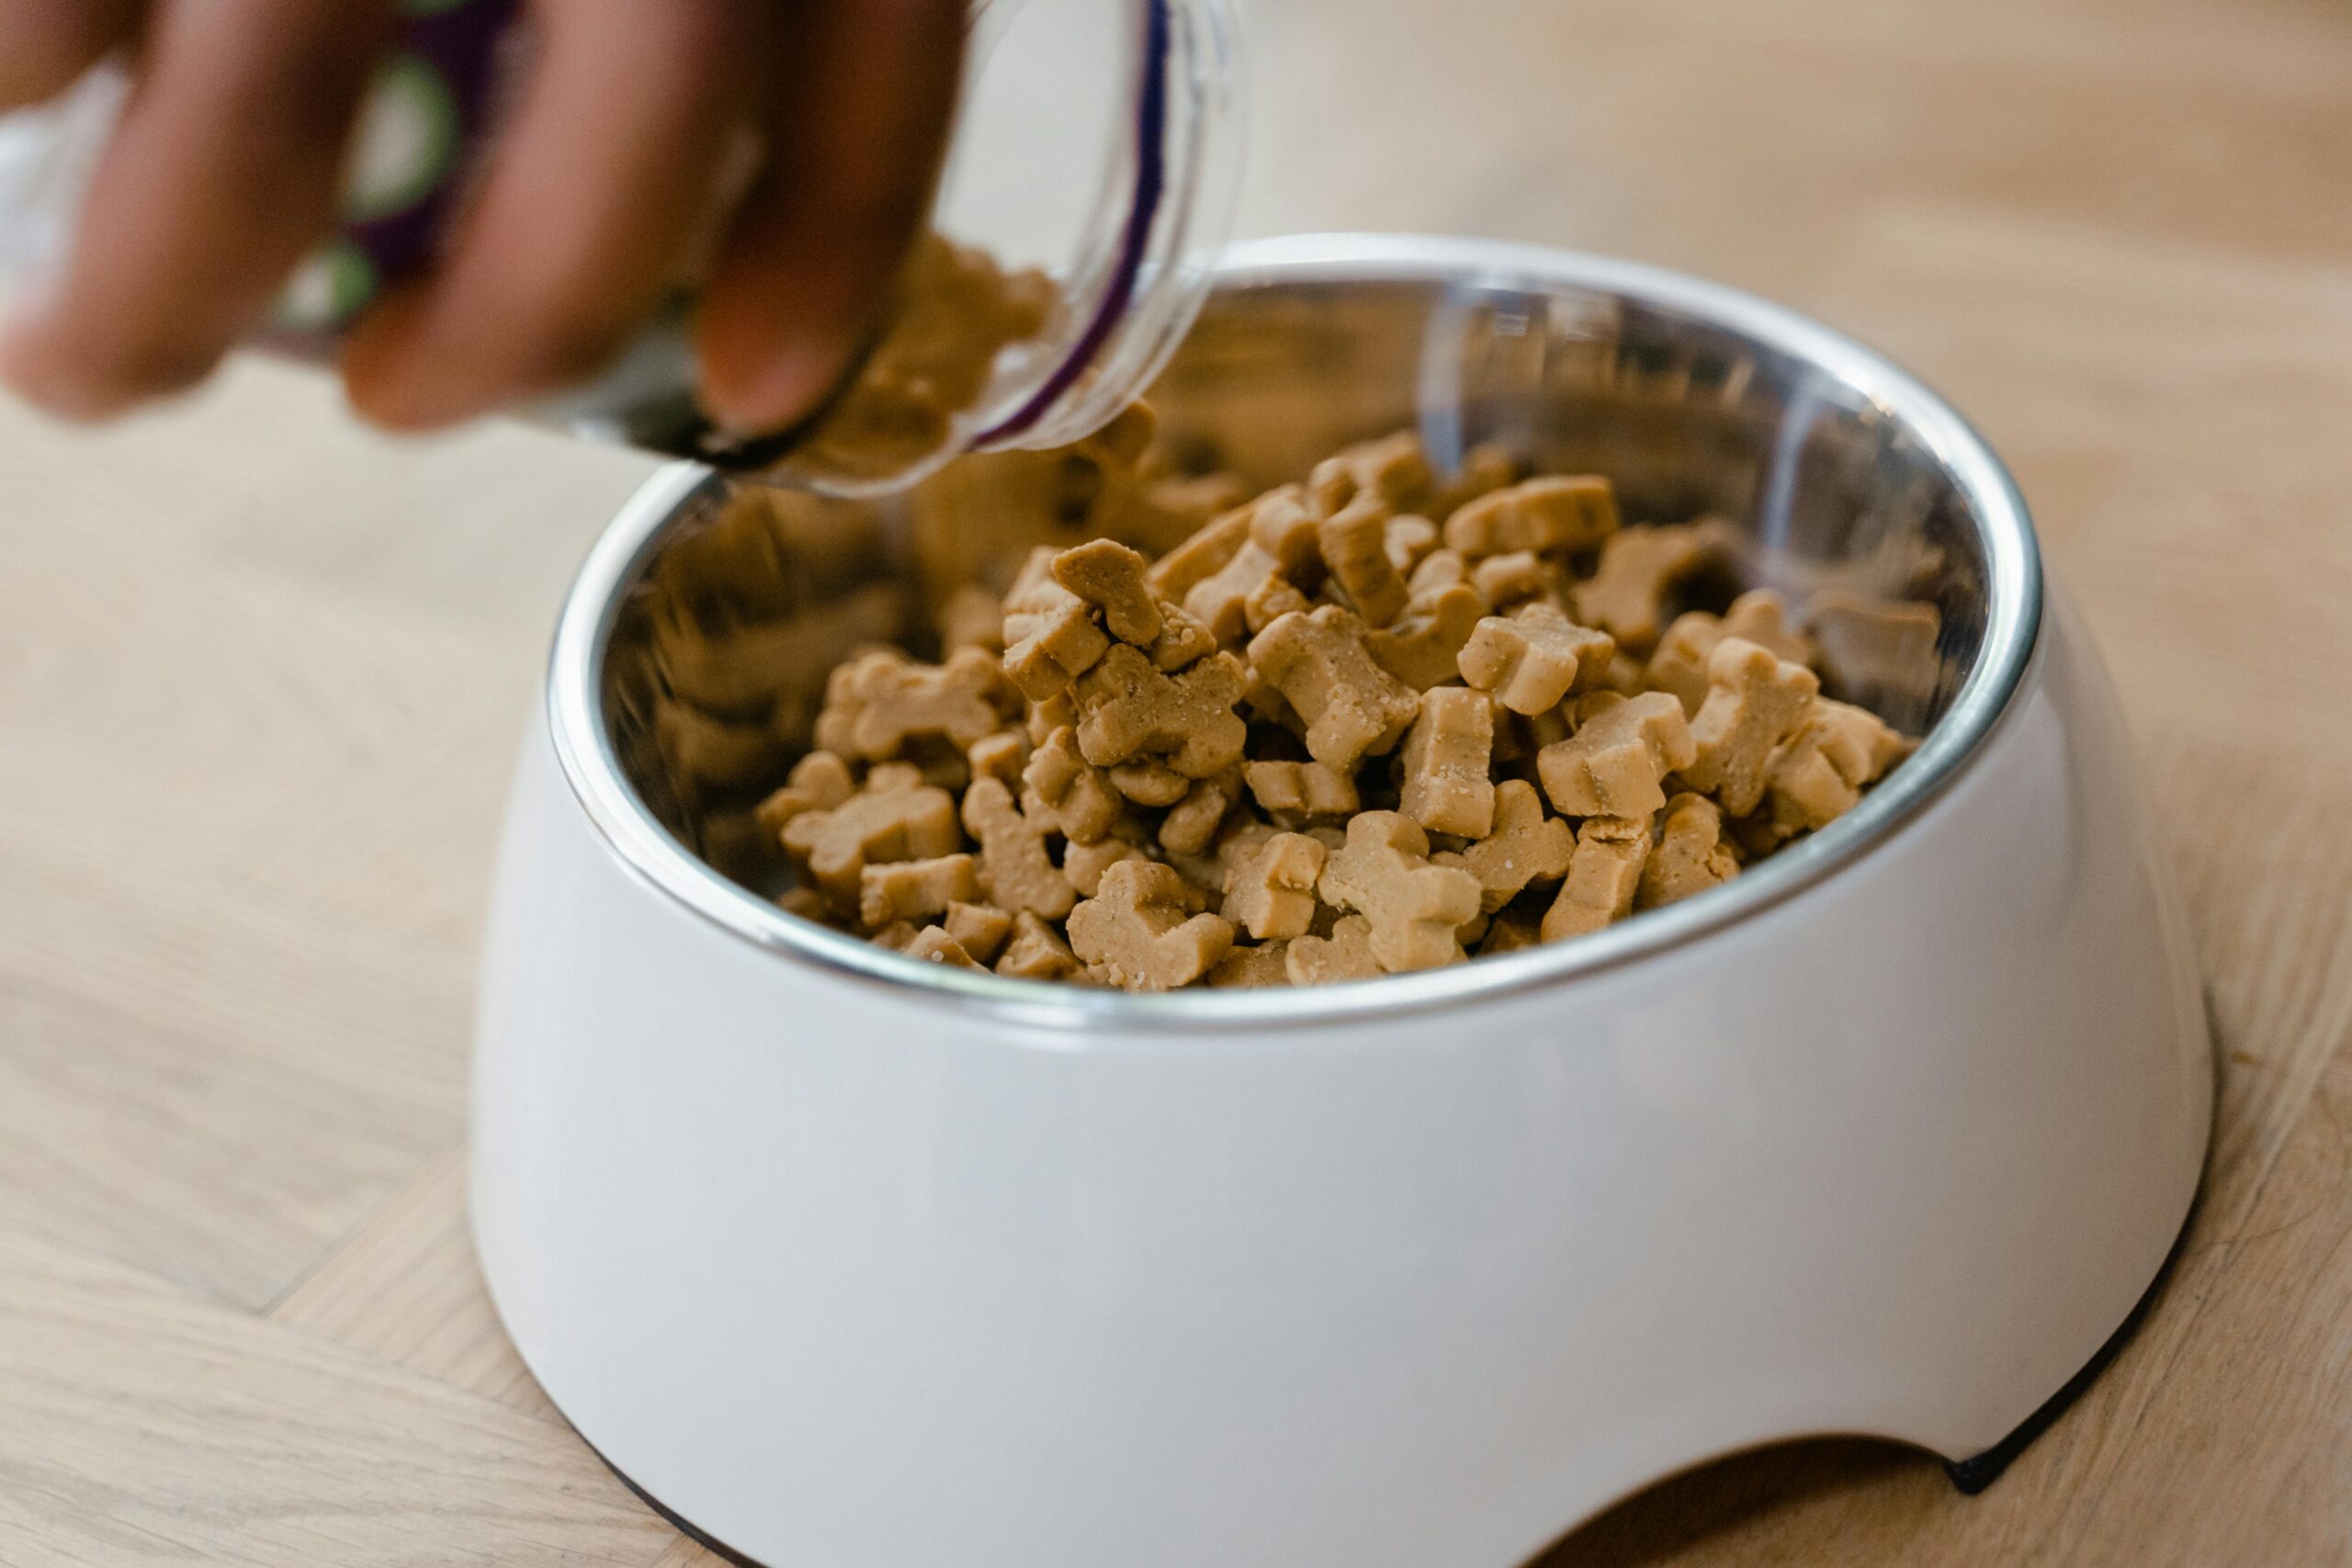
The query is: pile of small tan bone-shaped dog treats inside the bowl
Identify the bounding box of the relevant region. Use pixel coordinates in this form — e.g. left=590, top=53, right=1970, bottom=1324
left=755, top=434, right=1912, bottom=989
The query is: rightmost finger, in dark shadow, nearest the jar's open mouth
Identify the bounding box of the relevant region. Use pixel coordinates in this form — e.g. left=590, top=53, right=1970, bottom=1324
left=698, top=0, right=965, bottom=430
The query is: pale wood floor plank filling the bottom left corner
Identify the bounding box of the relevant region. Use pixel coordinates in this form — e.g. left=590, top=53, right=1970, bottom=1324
left=0, top=1235, right=673, bottom=1568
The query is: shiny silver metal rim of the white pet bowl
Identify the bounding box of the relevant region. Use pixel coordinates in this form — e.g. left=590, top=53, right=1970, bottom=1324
left=548, top=235, right=2041, bottom=1046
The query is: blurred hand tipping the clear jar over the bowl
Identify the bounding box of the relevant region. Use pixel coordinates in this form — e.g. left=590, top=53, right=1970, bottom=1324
left=0, top=0, right=965, bottom=430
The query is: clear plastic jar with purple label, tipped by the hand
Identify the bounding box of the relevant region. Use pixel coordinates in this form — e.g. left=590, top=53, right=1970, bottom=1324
left=0, top=0, right=1239, bottom=496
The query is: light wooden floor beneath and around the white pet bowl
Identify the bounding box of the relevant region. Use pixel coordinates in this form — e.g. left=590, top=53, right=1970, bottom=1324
left=0, top=0, right=2352, bottom=1568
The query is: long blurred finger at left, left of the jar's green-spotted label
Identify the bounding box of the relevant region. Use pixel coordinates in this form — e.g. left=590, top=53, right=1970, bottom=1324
left=0, top=0, right=388, bottom=419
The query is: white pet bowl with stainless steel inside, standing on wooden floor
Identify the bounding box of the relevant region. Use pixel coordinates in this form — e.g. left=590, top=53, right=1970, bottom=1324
left=473, top=237, right=2211, bottom=1568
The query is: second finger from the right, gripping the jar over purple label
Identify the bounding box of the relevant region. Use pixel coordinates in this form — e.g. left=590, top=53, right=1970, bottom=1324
left=344, top=0, right=764, bottom=430
